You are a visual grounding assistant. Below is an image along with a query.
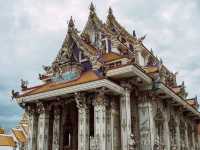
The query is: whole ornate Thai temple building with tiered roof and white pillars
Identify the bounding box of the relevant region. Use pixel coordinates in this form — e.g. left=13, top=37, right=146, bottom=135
left=12, top=4, right=200, bottom=150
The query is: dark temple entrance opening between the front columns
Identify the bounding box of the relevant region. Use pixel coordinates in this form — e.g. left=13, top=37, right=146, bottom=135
left=63, top=102, right=78, bottom=150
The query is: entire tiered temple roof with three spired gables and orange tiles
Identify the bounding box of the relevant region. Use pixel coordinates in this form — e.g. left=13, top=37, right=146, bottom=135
left=13, top=4, right=200, bottom=117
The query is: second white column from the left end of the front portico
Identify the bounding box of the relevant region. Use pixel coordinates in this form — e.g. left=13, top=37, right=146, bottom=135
left=37, top=103, right=49, bottom=150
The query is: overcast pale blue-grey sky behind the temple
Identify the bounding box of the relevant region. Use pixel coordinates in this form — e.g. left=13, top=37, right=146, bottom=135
left=0, top=0, right=200, bottom=131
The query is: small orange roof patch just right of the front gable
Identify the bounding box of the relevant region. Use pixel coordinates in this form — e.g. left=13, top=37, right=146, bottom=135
left=99, top=52, right=125, bottom=63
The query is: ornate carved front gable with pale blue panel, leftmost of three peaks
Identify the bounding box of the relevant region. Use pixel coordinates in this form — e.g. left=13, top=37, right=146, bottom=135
left=40, top=17, right=105, bottom=82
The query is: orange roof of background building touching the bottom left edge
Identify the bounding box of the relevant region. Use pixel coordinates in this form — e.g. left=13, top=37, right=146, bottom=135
left=0, top=134, right=16, bottom=147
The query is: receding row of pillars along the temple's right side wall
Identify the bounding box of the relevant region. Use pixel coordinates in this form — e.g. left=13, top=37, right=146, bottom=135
left=138, top=94, right=199, bottom=150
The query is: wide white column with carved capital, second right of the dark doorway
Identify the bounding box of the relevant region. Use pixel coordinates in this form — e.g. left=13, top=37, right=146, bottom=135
left=94, top=91, right=106, bottom=150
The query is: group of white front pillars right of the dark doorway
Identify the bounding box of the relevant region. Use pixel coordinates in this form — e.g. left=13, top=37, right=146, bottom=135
left=77, top=88, right=131, bottom=150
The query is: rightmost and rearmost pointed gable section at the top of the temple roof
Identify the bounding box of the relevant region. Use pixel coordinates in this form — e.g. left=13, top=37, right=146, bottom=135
left=106, top=8, right=156, bottom=66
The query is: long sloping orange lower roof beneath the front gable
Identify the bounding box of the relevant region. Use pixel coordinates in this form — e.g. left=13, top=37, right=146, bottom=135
left=19, top=71, right=102, bottom=97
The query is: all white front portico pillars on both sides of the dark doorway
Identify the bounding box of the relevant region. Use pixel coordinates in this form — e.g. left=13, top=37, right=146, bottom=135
left=26, top=85, right=131, bottom=150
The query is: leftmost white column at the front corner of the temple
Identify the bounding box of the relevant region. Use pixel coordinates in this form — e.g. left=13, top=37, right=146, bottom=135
left=26, top=106, right=38, bottom=150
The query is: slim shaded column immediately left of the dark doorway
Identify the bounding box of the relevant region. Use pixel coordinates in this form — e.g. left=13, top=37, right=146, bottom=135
left=52, top=106, right=61, bottom=150
